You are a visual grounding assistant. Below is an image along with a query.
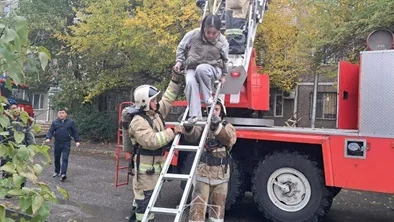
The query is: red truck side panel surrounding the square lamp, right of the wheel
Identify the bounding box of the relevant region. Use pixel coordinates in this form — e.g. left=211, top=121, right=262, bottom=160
left=325, top=136, right=394, bottom=193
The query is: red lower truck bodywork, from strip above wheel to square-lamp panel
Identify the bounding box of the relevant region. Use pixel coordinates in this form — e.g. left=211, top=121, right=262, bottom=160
left=237, top=130, right=394, bottom=193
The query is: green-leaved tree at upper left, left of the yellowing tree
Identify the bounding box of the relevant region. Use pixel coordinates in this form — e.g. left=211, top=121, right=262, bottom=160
left=17, top=0, right=83, bottom=89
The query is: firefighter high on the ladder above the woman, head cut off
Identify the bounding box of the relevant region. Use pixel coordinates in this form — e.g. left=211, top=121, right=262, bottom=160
left=226, top=0, right=250, bottom=54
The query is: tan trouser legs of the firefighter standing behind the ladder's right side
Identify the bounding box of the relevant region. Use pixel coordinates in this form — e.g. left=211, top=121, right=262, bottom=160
left=189, top=181, right=228, bottom=222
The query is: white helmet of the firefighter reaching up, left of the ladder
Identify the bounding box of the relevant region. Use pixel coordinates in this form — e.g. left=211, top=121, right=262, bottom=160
left=134, top=85, right=160, bottom=111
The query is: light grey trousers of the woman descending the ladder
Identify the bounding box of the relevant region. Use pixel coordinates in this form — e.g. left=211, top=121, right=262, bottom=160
left=186, top=64, right=222, bottom=117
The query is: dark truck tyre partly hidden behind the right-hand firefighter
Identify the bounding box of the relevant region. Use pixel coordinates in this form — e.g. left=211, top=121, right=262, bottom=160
left=226, top=159, right=247, bottom=211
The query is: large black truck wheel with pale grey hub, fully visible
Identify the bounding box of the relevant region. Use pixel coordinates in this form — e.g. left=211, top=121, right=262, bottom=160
left=252, top=151, right=332, bottom=222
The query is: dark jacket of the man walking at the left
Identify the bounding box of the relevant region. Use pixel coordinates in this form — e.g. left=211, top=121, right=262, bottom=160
left=46, top=118, right=79, bottom=142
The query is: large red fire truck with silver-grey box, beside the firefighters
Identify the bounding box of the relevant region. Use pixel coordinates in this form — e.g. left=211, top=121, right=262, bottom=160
left=116, top=1, right=394, bottom=222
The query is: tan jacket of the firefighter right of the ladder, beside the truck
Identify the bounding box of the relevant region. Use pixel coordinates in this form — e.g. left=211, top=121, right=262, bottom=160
left=184, top=121, right=237, bottom=185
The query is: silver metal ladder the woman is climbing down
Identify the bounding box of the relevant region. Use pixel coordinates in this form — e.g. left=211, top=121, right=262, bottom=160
left=142, top=0, right=267, bottom=222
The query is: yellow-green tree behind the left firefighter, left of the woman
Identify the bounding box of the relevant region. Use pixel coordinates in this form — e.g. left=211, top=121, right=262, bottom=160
left=59, top=0, right=199, bottom=101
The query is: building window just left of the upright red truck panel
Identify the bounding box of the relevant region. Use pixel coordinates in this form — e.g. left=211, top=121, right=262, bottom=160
left=310, top=92, right=337, bottom=120
